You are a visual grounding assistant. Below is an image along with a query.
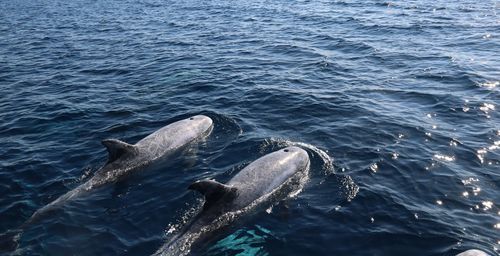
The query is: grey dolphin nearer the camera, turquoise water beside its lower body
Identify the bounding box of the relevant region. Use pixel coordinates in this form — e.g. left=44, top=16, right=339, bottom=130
left=153, top=146, right=310, bottom=256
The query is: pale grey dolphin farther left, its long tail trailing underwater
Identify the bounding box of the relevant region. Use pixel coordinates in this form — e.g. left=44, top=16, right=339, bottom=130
left=0, top=115, right=213, bottom=251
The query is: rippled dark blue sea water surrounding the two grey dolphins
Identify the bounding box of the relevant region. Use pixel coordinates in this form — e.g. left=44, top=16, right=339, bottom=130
left=0, top=0, right=500, bottom=255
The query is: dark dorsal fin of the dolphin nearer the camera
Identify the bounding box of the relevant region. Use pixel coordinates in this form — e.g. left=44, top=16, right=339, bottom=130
left=188, top=180, right=237, bottom=208
